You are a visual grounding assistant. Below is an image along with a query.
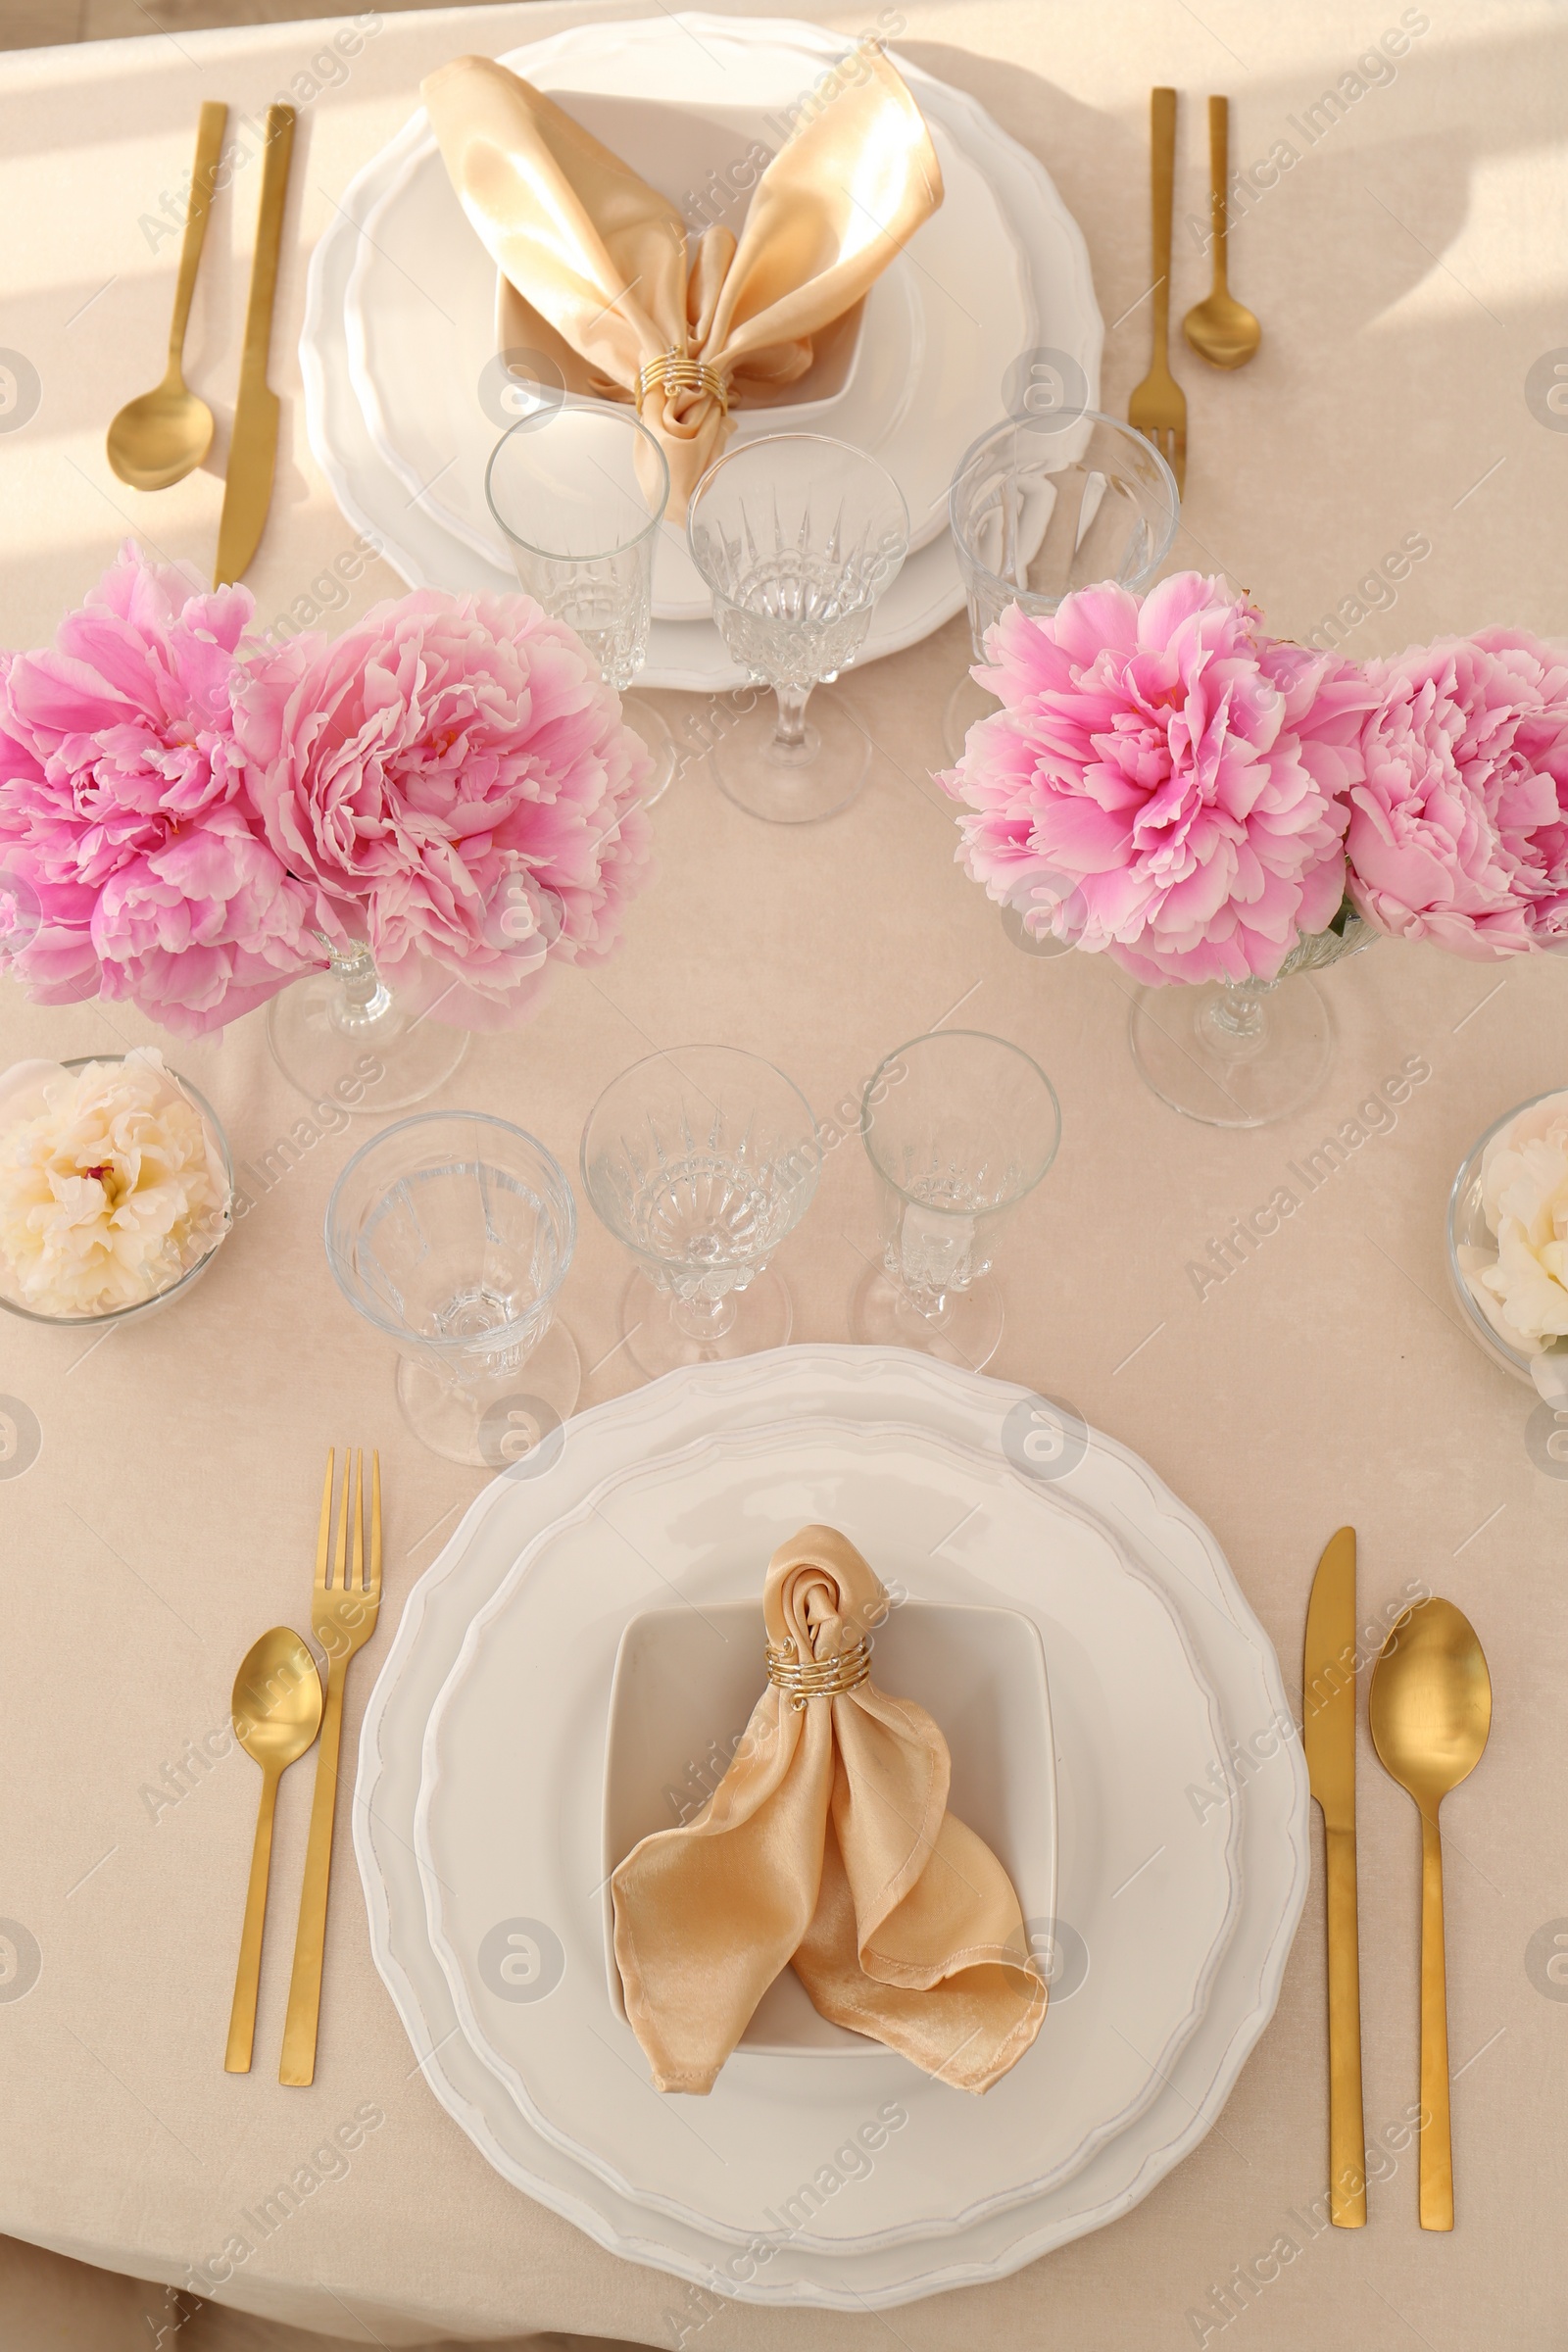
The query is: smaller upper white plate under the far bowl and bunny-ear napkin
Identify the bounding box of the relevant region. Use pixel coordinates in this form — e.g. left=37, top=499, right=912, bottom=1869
left=346, top=74, right=1032, bottom=621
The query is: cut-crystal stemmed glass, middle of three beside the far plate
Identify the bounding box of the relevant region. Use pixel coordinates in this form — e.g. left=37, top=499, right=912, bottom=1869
left=686, top=433, right=909, bottom=825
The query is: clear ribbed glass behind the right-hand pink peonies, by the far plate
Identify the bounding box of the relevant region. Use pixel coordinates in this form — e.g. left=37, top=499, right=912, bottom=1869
left=943, top=410, right=1180, bottom=760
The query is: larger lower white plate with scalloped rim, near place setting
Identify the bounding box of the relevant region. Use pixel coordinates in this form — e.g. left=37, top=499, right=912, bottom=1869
left=355, top=1348, right=1309, bottom=2310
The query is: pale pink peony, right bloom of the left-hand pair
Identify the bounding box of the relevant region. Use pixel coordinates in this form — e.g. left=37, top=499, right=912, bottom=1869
left=235, top=588, right=651, bottom=1028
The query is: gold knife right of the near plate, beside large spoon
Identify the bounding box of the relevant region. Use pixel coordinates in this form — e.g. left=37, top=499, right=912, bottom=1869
left=1302, top=1527, right=1366, bottom=2230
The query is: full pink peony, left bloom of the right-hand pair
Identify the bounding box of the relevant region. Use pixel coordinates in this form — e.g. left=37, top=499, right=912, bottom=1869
left=941, top=571, right=1368, bottom=981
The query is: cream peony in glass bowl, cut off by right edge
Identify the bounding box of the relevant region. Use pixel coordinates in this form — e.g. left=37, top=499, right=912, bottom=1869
left=1460, top=1094, right=1568, bottom=1395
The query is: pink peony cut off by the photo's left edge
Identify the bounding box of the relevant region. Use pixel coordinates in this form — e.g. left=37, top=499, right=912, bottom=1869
left=0, top=541, right=324, bottom=1035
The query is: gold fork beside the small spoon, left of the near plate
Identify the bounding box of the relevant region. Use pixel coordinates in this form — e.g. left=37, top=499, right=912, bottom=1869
left=277, top=1446, right=381, bottom=2083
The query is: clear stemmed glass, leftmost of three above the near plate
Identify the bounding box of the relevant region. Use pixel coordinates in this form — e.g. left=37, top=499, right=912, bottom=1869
left=326, top=1110, right=581, bottom=1470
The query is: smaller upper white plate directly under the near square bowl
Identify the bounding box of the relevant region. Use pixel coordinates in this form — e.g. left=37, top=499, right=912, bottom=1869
left=414, top=1421, right=1239, bottom=2251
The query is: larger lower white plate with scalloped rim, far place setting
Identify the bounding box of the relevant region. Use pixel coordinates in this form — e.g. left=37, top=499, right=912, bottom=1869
left=299, top=14, right=1102, bottom=694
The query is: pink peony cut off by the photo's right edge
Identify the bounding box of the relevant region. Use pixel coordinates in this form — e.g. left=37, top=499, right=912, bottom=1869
left=1348, top=628, right=1568, bottom=957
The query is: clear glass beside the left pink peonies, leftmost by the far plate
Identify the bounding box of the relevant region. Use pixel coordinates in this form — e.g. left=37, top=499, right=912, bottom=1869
left=484, top=400, right=674, bottom=807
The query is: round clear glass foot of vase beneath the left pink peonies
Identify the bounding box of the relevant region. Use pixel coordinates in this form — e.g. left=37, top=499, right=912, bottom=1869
left=266, top=955, right=467, bottom=1112
